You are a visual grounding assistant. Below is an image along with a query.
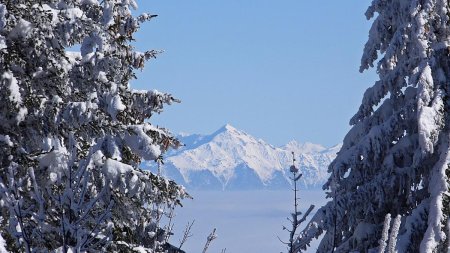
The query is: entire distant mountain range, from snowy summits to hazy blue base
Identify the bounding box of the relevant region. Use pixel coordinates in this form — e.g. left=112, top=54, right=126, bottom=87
left=144, top=125, right=341, bottom=190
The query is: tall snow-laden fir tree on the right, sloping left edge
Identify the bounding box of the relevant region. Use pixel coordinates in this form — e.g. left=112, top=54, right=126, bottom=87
left=296, top=0, right=450, bottom=253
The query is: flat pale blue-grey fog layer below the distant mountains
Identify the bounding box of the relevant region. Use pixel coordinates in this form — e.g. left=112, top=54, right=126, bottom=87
left=167, top=190, right=325, bottom=253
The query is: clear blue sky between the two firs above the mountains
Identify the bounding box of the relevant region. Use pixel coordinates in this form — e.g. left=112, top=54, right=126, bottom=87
left=132, top=0, right=376, bottom=146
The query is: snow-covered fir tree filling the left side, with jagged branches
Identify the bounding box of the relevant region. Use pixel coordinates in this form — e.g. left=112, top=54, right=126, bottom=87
left=0, top=0, right=186, bottom=253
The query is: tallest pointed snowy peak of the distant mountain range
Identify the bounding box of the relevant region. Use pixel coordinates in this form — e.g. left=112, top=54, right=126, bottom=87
left=171, top=124, right=282, bottom=184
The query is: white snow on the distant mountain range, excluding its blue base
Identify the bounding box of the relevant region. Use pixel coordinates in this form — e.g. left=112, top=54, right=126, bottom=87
left=160, top=124, right=340, bottom=190
